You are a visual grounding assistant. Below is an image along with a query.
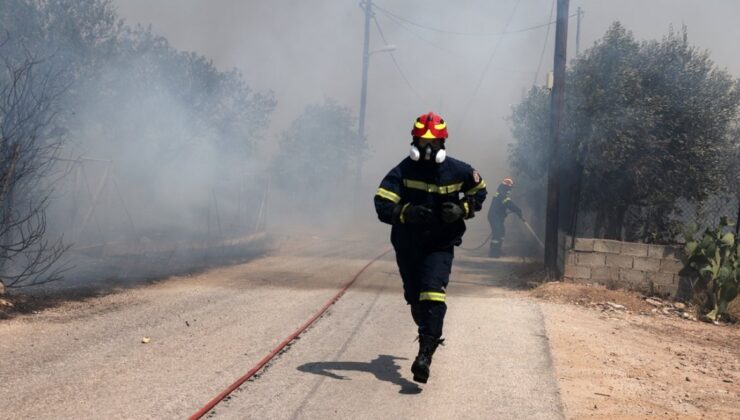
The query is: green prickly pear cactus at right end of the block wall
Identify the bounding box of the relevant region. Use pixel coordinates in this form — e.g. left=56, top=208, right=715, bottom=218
left=679, top=217, right=740, bottom=322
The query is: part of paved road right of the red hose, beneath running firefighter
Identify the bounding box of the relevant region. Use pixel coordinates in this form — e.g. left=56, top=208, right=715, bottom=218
left=215, top=253, right=562, bottom=419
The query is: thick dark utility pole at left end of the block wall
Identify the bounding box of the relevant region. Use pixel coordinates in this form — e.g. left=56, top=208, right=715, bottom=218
left=545, top=0, right=570, bottom=279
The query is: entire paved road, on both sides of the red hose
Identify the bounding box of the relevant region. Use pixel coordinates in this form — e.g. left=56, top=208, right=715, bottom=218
left=0, top=233, right=563, bottom=419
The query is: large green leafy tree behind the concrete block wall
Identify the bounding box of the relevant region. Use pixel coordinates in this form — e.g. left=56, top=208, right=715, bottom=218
left=510, top=23, right=740, bottom=240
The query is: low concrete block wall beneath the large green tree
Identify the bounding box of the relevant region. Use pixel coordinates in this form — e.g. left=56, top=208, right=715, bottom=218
left=564, top=238, right=682, bottom=296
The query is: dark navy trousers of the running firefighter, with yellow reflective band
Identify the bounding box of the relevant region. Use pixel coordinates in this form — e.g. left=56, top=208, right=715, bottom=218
left=396, top=247, right=454, bottom=338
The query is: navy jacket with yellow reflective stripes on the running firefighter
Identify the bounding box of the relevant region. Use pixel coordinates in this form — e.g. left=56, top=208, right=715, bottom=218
left=375, top=157, right=487, bottom=253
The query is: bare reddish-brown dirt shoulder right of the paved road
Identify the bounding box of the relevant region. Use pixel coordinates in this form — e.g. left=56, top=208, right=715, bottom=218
left=531, top=282, right=740, bottom=419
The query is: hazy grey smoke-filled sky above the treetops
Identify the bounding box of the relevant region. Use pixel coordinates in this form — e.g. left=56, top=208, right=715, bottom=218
left=114, top=0, right=740, bottom=195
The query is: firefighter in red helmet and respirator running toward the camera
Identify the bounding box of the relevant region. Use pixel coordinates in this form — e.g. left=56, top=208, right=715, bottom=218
left=374, top=112, right=486, bottom=383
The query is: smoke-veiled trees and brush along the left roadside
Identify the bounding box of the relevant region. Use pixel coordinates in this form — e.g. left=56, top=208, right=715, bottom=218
left=0, top=0, right=276, bottom=288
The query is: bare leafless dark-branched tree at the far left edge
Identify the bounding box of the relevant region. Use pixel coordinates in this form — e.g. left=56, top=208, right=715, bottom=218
left=0, top=39, right=69, bottom=287
